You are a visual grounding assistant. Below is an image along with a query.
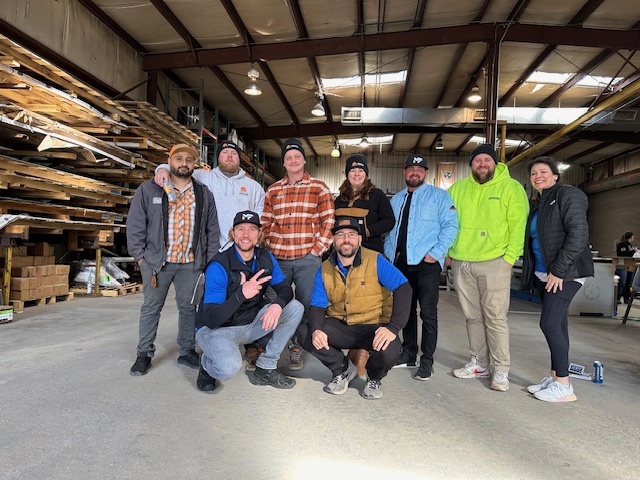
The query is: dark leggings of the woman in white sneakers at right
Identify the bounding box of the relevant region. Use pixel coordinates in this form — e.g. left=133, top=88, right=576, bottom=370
left=535, top=277, right=582, bottom=377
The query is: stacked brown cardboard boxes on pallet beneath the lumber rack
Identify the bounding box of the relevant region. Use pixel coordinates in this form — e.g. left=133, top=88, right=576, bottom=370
left=9, top=243, right=69, bottom=301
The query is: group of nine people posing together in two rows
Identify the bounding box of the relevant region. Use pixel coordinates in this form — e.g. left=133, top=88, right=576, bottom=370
left=127, top=138, right=593, bottom=402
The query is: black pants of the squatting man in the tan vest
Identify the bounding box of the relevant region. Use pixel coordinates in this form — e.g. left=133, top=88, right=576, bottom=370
left=298, top=317, right=401, bottom=380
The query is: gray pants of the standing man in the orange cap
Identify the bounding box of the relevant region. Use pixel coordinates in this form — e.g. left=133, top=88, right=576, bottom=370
left=138, top=260, right=201, bottom=357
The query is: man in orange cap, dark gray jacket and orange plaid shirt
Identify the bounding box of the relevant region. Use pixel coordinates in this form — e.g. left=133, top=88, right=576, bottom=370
left=127, top=144, right=220, bottom=375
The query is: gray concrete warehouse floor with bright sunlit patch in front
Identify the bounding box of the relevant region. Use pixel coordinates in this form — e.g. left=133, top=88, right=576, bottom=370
left=0, top=291, right=640, bottom=480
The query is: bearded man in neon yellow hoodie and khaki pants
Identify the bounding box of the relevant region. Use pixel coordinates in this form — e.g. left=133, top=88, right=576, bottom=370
left=449, top=144, right=529, bottom=392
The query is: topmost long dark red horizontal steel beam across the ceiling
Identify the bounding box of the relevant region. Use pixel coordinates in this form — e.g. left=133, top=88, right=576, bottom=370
left=143, top=23, right=640, bottom=70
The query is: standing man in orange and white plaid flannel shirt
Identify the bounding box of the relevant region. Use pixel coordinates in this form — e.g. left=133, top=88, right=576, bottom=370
left=261, top=138, right=334, bottom=370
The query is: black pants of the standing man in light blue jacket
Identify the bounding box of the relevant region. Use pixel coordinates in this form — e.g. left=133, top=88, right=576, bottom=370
left=396, top=262, right=442, bottom=368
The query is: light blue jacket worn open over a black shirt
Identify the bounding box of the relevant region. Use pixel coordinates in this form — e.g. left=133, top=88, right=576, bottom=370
left=384, top=184, right=458, bottom=267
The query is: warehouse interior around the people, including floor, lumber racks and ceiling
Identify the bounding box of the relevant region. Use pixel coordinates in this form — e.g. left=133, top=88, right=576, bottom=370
left=0, top=0, right=640, bottom=479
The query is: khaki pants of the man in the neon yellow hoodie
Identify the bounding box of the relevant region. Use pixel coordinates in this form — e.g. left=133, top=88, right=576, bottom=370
left=452, top=257, right=511, bottom=373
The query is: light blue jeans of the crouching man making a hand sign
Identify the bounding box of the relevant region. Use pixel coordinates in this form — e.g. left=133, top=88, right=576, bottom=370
left=196, top=300, right=303, bottom=380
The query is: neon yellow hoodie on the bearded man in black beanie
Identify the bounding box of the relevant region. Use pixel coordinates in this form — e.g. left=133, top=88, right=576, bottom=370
left=448, top=163, right=529, bottom=265
